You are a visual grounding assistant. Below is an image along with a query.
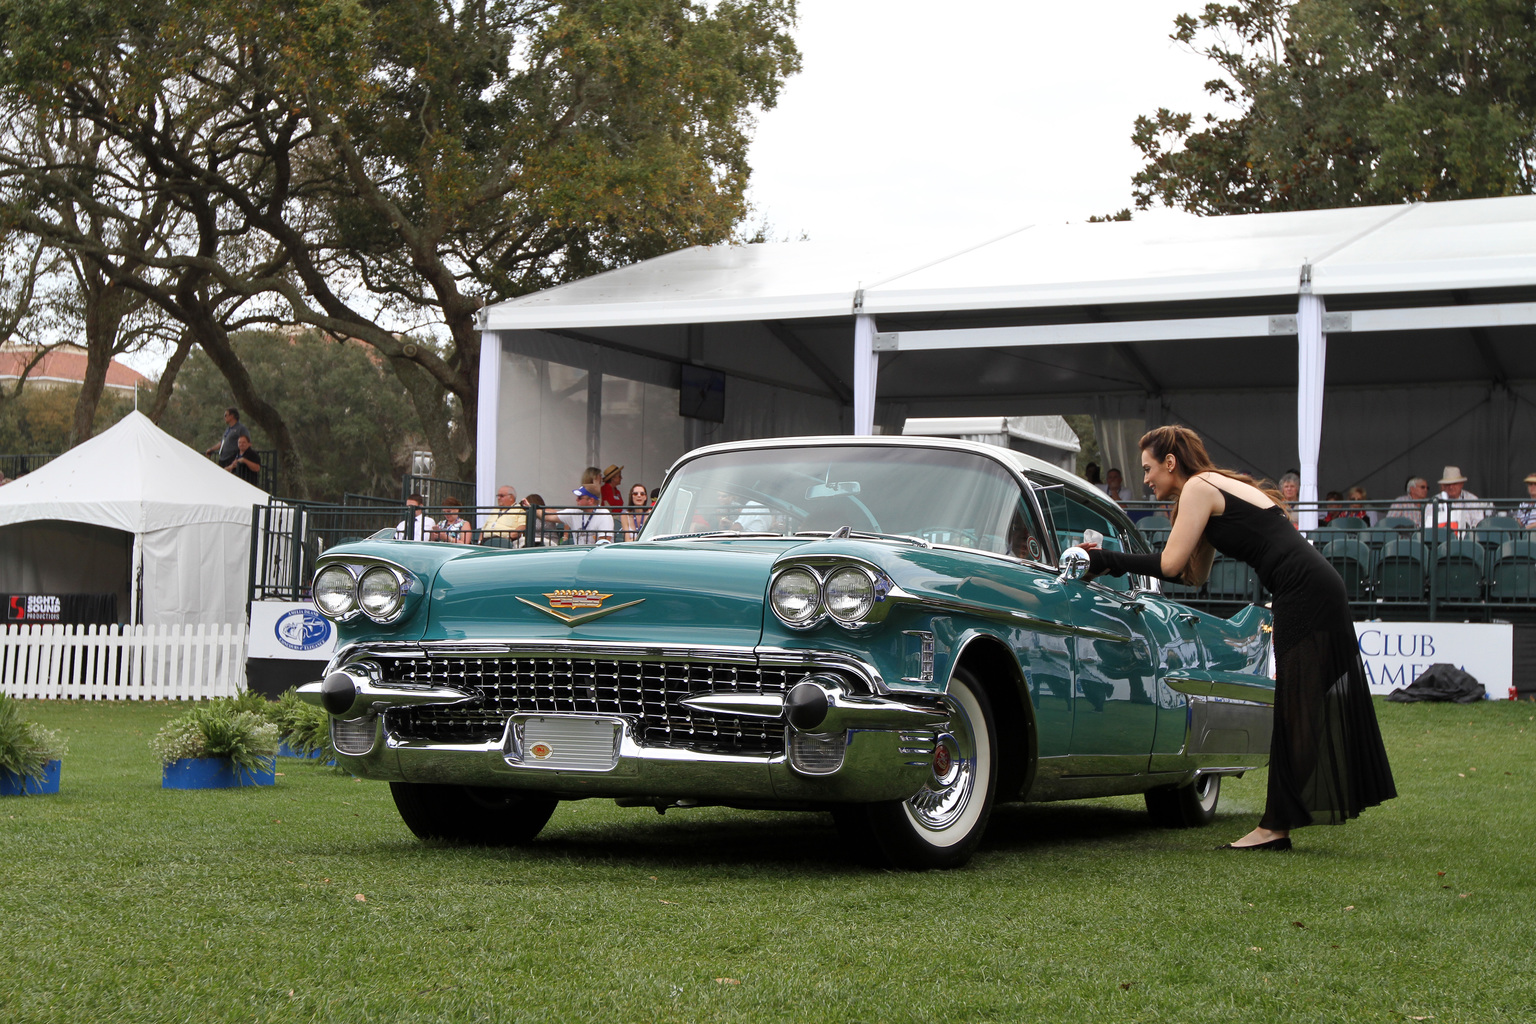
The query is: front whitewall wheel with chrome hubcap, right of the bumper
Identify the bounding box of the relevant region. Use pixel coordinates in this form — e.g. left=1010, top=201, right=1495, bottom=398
left=833, top=669, right=997, bottom=870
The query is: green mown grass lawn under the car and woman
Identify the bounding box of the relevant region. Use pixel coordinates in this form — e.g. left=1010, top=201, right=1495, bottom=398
left=0, top=702, right=1536, bottom=1024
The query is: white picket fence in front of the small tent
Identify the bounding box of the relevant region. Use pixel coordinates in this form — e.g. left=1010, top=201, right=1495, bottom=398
left=0, top=622, right=246, bottom=700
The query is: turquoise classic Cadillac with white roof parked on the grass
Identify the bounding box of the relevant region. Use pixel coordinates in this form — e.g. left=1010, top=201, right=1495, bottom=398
left=301, top=438, right=1273, bottom=869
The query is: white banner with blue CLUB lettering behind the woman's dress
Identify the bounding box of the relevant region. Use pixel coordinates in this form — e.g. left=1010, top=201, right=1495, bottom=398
left=1355, top=622, right=1514, bottom=700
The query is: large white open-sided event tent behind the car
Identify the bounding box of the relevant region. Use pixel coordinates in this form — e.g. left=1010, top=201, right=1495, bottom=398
left=478, top=197, right=1536, bottom=528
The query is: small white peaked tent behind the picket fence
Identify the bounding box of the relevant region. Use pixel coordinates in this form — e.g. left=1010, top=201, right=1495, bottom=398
left=0, top=411, right=267, bottom=625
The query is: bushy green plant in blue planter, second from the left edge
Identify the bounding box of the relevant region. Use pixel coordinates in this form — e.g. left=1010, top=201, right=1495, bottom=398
left=151, top=695, right=278, bottom=789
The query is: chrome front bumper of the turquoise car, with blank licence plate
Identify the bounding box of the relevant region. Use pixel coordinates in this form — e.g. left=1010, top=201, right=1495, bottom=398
left=300, top=645, right=951, bottom=803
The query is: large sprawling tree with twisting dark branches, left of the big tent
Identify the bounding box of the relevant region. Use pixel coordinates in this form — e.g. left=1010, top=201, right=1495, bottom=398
left=0, top=0, right=799, bottom=476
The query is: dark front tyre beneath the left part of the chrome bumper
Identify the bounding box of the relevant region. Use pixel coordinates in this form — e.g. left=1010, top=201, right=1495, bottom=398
left=389, top=783, right=559, bottom=846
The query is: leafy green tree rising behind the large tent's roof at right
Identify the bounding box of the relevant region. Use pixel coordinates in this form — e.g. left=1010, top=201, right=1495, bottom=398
left=1132, top=0, right=1536, bottom=213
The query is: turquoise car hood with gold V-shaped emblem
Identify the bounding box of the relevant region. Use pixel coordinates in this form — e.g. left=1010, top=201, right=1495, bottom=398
left=422, top=540, right=803, bottom=646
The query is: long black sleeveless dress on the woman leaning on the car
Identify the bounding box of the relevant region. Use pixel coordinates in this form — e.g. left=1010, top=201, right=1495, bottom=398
left=1206, top=488, right=1398, bottom=831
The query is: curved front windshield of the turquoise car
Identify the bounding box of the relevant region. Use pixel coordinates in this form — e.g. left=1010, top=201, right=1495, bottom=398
left=641, top=445, right=1038, bottom=553
